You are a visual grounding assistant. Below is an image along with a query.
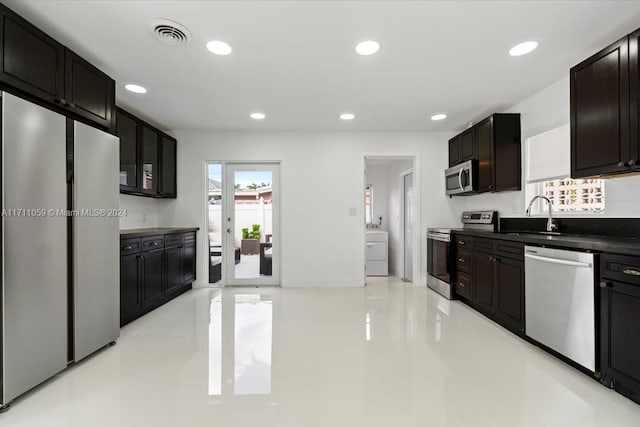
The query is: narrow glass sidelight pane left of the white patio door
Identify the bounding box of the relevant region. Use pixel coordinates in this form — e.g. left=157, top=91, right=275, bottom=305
left=207, top=163, right=223, bottom=283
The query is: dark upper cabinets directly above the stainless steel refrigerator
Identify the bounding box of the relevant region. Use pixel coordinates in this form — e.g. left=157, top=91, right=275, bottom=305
left=0, top=4, right=115, bottom=131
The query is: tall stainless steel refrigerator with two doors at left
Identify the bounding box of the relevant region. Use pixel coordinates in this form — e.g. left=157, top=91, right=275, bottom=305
left=0, top=92, right=119, bottom=409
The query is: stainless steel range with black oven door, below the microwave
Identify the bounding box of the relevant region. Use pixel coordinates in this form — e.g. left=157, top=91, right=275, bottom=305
left=427, top=211, right=498, bottom=299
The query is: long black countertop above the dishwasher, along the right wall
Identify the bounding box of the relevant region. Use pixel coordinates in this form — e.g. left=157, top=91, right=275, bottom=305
left=451, top=229, right=640, bottom=256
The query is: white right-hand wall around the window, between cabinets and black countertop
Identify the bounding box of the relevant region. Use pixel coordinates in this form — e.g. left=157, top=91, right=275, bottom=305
left=449, top=77, right=640, bottom=219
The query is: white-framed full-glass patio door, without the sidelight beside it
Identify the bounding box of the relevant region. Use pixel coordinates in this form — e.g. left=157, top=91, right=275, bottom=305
left=222, top=163, right=280, bottom=286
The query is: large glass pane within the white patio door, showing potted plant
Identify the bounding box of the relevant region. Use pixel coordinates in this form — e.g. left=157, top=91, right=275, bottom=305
left=234, top=169, right=273, bottom=279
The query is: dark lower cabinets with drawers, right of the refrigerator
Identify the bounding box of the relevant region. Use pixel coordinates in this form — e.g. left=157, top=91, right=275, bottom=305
left=120, top=229, right=196, bottom=326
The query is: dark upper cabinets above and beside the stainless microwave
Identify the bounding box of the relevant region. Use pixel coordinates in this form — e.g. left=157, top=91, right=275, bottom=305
left=449, top=114, right=522, bottom=193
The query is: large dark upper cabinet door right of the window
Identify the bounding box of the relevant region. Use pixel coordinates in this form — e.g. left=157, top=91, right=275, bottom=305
left=570, top=37, right=638, bottom=178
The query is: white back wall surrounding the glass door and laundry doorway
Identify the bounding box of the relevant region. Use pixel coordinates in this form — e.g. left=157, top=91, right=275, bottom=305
left=164, top=131, right=457, bottom=287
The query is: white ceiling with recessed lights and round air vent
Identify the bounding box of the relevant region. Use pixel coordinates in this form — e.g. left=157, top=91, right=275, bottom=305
left=5, top=0, right=640, bottom=130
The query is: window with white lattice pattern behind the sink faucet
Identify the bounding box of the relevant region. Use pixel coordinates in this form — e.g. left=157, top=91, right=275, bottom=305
left=537, top=178, right=605, bottom=213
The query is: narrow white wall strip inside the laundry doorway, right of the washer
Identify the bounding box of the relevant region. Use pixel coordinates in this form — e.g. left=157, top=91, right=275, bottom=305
left=387, top=159, right=412, bottom=280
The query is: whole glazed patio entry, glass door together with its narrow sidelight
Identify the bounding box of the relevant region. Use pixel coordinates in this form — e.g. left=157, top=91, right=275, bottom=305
left=207, top=162, right=280, bottom=286
